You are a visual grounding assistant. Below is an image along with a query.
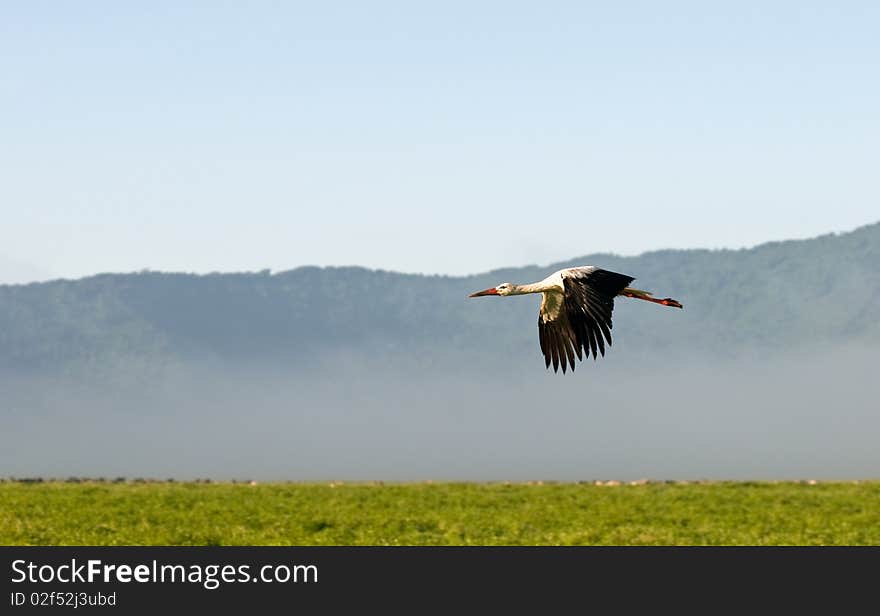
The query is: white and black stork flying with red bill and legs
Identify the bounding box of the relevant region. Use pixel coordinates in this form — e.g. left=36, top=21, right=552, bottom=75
left=469, top=265, right=682, bottom=374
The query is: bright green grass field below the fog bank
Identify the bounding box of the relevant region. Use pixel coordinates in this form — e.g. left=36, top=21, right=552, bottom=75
left=0, top=481, right=880, bottom=545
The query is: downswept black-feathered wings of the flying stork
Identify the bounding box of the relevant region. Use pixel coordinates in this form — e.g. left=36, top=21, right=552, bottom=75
left=538, top=267, right=635, bottom=373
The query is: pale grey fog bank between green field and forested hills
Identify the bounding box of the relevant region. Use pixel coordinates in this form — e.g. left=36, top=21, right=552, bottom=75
left=0, top=342, right=880, bottom=481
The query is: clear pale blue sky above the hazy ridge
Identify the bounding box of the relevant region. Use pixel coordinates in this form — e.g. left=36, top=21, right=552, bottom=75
left=0, top=2, right=880, bottom=281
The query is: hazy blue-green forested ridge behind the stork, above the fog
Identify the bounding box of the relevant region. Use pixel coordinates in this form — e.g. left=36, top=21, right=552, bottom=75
left=0, top=223, right=880, bottom=374
